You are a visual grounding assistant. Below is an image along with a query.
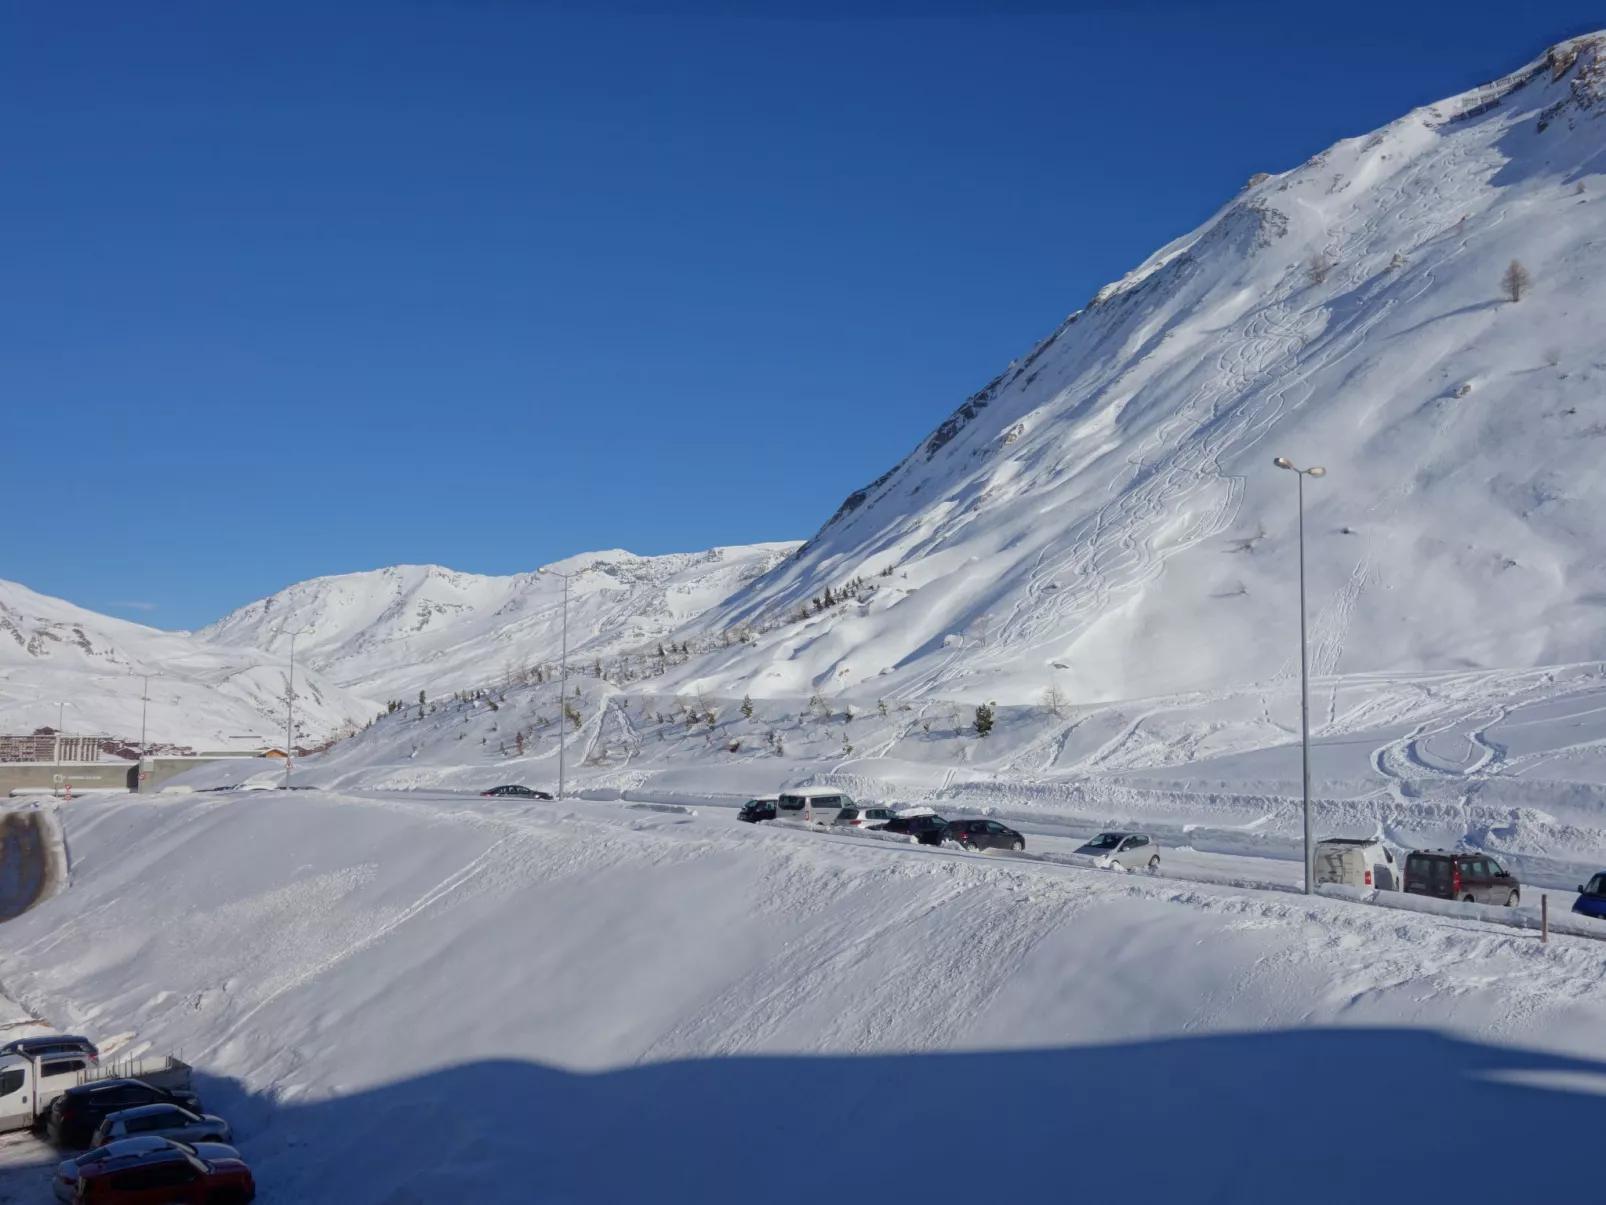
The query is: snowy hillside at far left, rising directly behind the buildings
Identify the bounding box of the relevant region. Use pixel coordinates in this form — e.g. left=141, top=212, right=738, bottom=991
left=0, top=582, right=366, bottom=750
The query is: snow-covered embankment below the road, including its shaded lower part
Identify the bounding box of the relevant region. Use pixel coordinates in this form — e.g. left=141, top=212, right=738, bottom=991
left=0, top=790, right=1606, bottom=1205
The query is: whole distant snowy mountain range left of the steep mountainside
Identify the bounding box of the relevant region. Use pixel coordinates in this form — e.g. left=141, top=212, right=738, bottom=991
left=0, top=541, right=798, bottom=749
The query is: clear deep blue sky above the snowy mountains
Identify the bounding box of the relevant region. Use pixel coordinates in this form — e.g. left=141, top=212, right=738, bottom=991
left=0, top=0, right=1606, bottom=627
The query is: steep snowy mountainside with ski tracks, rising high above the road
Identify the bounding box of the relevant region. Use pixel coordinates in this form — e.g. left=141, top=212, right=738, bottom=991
left=664, top=35, right=1606, bottom=702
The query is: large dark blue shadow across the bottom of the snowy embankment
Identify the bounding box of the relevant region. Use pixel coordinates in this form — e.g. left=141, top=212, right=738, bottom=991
left=141, top=1028, right=1606, bottom=1205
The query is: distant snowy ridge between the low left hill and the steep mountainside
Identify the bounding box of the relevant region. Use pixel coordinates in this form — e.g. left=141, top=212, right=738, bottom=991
left=198, top=543, right=797, bottom=699
